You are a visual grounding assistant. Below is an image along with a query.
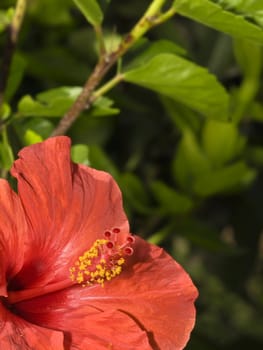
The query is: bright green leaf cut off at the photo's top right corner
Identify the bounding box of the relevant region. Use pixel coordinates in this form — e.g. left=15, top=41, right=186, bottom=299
left=173, top=0, right=263, bottom=44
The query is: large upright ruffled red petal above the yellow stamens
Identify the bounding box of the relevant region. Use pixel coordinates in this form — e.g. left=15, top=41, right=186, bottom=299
left=11, top=136, right=129, bottom=288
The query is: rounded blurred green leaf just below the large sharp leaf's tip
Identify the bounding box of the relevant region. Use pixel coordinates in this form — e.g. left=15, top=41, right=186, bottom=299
left=202, top=120, right=246, bottom=168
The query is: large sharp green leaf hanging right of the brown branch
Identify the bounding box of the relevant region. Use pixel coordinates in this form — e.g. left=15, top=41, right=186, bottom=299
left=124, top=53, right=228, bottom=120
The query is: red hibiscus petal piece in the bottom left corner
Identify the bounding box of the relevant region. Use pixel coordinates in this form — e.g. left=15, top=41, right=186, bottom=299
left=0, top=303, right=65, bottom=350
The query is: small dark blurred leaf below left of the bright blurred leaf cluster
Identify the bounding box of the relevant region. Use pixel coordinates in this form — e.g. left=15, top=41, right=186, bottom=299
left=151, top=181, right=194, bottom=215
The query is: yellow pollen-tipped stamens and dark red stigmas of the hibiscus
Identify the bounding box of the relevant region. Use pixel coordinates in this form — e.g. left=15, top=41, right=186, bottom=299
left=70, top=228, right=135, bottom=287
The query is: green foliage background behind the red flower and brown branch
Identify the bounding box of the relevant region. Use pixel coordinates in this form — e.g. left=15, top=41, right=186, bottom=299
left=0, top=0, right=263, bottom=350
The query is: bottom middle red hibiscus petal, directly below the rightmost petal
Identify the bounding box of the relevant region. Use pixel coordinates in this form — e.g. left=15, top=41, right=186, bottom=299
left=15, top=298, right=152, bottom=350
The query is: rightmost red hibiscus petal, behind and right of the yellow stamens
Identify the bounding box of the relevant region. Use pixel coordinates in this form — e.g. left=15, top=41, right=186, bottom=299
left=77, top=237, right=198, bottom=350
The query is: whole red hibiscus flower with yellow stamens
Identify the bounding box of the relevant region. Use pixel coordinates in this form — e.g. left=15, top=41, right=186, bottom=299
left=0, top=137, right=197, bottom=350
